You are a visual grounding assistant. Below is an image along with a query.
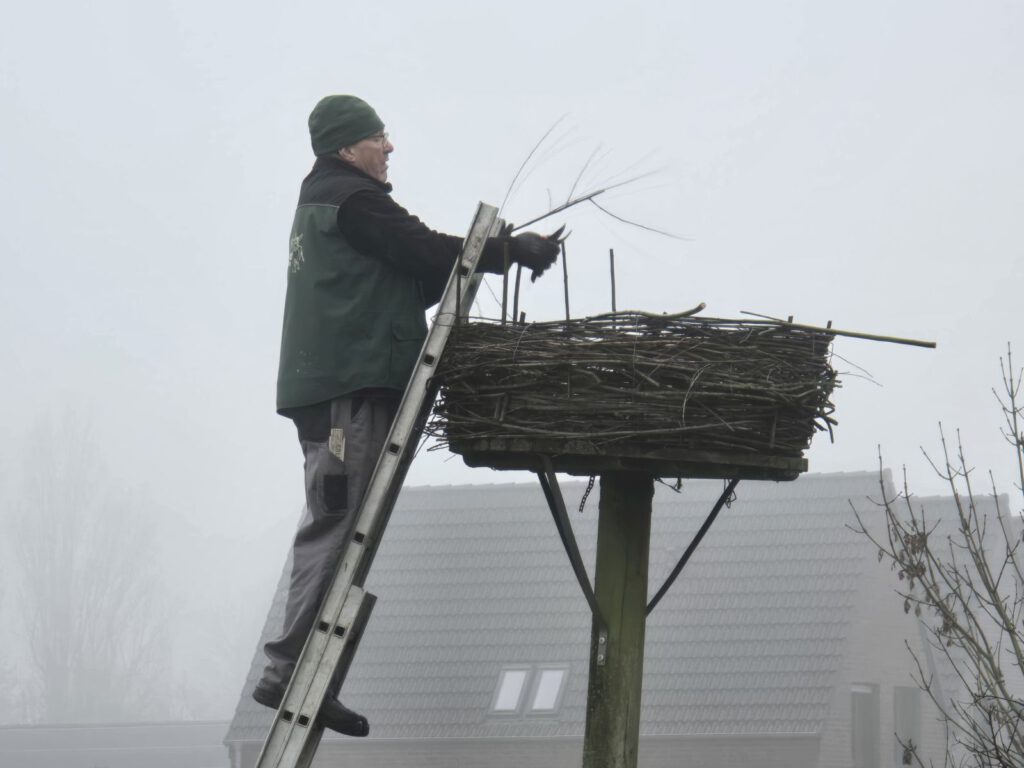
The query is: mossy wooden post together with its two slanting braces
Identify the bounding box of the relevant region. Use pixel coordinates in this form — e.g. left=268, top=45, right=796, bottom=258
left=537, top=466, right=739, bottom=768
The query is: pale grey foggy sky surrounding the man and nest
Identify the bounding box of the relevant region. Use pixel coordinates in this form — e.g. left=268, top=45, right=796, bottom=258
left=0, top=0, right=1024, bottom=720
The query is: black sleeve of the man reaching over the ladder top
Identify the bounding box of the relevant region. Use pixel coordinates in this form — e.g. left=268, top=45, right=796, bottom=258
left=338, top=190, right=511, bottom=306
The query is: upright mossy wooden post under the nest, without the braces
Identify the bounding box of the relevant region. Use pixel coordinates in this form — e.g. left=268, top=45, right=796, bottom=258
left=583, top=472, right=654, bottom=768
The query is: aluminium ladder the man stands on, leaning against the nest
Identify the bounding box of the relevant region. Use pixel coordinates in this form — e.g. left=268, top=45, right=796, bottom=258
left=256, top=203, right=498, bottom=768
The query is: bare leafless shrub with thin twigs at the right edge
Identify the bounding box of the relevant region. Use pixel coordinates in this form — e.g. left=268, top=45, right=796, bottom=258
left=857, top=349, right=1024, bottom=768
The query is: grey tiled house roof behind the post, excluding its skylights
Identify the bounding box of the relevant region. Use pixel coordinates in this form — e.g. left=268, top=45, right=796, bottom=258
left=226, top=472, right=879, bottom=741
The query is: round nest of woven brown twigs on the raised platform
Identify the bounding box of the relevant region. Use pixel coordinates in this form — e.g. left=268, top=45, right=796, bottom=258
left=428, top=312, right=837, bottom=458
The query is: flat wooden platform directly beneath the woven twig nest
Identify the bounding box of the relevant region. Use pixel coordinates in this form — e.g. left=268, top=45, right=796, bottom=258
left=450, top=437, right=807, bottom=481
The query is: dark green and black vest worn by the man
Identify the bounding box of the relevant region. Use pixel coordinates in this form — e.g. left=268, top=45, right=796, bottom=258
left=278, top=159, right=427, bottom=412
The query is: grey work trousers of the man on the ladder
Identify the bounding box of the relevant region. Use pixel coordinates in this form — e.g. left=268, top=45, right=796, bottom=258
left=260, top=390, right=400, bottom=696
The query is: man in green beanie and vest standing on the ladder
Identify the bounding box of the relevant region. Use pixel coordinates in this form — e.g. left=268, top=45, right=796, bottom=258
left=253, top=95, right=559, bottom=736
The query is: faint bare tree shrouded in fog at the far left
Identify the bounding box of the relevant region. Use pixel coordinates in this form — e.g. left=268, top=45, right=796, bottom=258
left=2, top=413, right=170, bottom=723
